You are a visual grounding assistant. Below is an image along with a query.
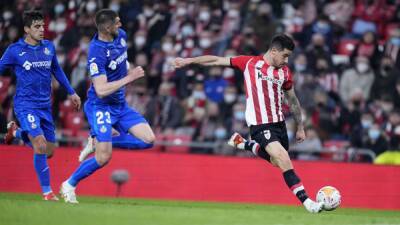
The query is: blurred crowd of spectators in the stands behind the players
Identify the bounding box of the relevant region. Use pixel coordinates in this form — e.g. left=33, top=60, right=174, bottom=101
left=0, top=0, right=400, bottom=162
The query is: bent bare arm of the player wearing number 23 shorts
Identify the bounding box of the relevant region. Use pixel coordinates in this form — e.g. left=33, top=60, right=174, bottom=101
left=92, top=66, right=144, bottom=98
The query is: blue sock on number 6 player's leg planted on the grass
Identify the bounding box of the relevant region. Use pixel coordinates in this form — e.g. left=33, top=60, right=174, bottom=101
left=33, top=153, right=51, bottom=194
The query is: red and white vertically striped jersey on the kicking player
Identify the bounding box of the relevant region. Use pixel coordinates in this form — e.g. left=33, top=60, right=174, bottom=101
left=231, top=56, right=293, bottom=126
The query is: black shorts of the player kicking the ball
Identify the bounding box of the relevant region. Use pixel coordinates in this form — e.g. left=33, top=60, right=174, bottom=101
left=250, top=121, right=289, bottom=151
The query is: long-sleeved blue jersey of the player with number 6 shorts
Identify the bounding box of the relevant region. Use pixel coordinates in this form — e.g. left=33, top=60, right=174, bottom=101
left=0, top=38, right=74, bottom=108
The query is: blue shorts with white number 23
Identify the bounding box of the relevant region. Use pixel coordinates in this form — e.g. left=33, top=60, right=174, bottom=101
left=84, top=101, right=147, bottom=142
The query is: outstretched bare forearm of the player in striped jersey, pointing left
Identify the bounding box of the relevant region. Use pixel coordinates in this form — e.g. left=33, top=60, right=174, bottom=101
left=172, top=55, right=231, bottom=68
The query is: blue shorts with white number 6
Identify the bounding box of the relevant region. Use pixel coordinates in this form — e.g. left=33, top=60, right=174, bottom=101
left=14, top=107, right=56, bottom=143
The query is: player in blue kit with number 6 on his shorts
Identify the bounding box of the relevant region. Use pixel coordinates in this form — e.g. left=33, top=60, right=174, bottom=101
left=0, top=11, right=81, bottom=200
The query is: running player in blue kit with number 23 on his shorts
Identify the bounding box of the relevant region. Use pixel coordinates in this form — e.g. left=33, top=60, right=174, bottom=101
left=60, top=9, right=155, bottom=203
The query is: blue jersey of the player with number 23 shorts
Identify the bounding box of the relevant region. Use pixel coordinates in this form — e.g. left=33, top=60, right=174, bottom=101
left=87, top=29, right=128, bottom=105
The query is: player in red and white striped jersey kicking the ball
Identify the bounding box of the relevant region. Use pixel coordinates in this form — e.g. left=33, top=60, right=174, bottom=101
left=173, top=34, right=323, bottom=213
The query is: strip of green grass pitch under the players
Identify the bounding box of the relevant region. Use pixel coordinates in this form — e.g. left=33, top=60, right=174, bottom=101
left=0, top=193, right=400, bottom=225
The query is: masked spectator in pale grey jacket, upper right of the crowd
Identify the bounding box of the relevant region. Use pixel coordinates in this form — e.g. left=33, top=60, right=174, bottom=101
left=339, top=56, right=375, bottom=102
